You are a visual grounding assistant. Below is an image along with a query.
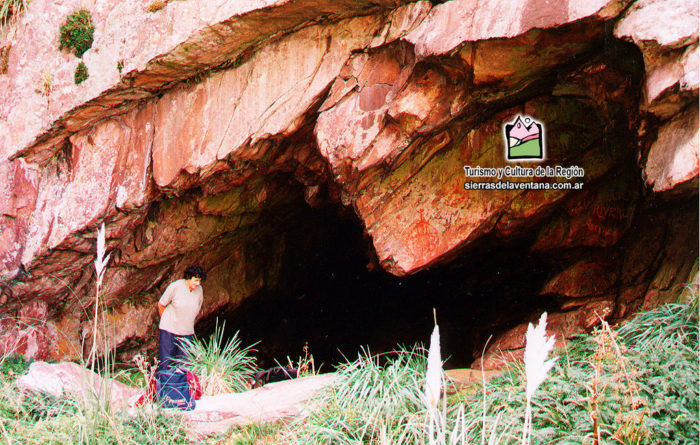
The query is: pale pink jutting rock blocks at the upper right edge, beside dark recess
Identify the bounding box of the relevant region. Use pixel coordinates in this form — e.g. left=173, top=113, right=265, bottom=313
left=615, top=0, right=700, bottom=192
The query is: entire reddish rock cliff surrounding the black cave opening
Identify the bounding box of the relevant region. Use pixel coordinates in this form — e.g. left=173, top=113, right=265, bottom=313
left=0, top=0, right=700, bottom=358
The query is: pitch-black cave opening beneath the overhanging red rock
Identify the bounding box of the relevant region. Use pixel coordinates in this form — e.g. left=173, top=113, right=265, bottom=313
left=197, top=196, right=553, bottom=371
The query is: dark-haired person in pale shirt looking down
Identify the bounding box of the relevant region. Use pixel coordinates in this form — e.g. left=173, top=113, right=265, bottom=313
left=158, top=264, right=207, bottom=370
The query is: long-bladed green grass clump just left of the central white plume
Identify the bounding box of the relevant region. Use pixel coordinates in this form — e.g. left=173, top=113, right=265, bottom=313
left=291, top=348, right=427, bottom=445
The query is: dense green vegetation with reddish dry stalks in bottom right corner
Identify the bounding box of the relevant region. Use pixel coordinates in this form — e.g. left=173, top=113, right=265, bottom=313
left=465, top=294, right=699, bottom=444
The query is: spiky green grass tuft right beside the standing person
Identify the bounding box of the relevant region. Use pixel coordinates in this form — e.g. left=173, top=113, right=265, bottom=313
left=178, top=320, right=257, bottom=395
